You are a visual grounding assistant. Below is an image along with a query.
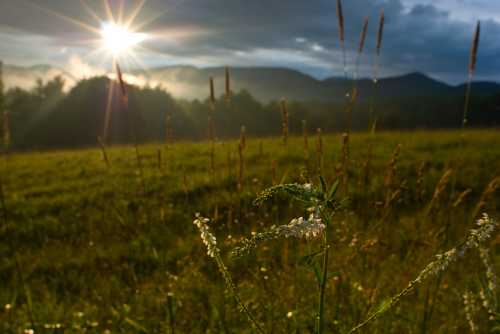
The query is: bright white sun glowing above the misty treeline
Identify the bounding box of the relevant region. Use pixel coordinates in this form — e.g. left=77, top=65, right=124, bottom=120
left=100, top=22, right=148, bottom=58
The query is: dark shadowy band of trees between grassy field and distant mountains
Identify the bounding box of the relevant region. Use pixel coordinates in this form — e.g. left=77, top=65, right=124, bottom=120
left=6, top=75, right=500, bottom=149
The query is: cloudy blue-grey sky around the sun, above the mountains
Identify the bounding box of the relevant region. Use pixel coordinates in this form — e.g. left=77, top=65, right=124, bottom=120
left=0, top=0, right=500, bottom=83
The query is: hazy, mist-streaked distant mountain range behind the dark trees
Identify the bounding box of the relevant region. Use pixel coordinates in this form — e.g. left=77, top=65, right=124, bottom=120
left=4, top=65, right=500, bottom=102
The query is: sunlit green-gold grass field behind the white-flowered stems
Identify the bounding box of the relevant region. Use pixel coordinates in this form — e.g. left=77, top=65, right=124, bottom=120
left=0, top=130, right=500, bottom=333
